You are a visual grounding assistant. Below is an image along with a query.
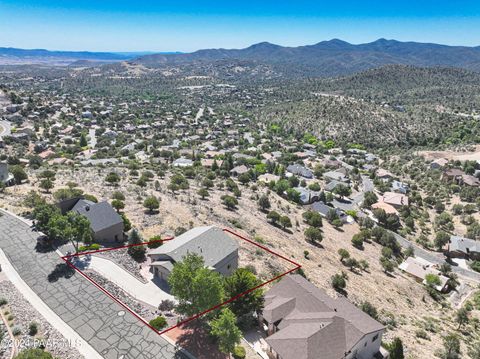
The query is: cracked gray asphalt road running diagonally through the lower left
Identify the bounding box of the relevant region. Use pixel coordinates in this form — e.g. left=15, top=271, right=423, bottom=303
left=0, top=212, right=180, bottom=359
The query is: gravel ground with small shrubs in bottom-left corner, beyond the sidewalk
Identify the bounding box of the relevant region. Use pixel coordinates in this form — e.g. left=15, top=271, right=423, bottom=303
left=0, top=280, right=84, bottom=359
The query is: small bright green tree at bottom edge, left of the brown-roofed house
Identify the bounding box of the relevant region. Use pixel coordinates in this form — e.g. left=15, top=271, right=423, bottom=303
left=210, top=308, right=242, bottom=357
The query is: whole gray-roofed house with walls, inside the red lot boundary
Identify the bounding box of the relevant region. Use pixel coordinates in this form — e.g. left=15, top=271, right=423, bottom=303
left=147, top=226, right=239, bottom=280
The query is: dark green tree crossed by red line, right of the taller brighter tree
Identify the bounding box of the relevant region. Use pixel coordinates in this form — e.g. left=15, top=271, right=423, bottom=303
left=224, top=268, right=264, bottom=318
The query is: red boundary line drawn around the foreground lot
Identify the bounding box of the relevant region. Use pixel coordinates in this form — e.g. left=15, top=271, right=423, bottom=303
left=61, top=228, right=301, bottom=335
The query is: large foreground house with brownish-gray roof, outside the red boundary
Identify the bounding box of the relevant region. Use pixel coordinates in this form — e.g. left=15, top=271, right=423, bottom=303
left=260, top=275, right=385, bottom=359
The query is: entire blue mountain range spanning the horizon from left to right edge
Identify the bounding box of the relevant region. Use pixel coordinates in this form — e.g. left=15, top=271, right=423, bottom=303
left=0, top=39, right=480, bottom=77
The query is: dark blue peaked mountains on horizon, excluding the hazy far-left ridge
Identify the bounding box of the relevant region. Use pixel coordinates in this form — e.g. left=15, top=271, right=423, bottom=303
left=133, top=39, right=480, bottom=76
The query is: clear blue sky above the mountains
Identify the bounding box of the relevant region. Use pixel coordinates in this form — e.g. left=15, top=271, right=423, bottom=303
left=0, top=0, right=480, bottom=52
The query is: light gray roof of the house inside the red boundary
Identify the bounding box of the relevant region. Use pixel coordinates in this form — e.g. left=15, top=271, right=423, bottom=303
left=148, top=226, right=238, bottom=267
